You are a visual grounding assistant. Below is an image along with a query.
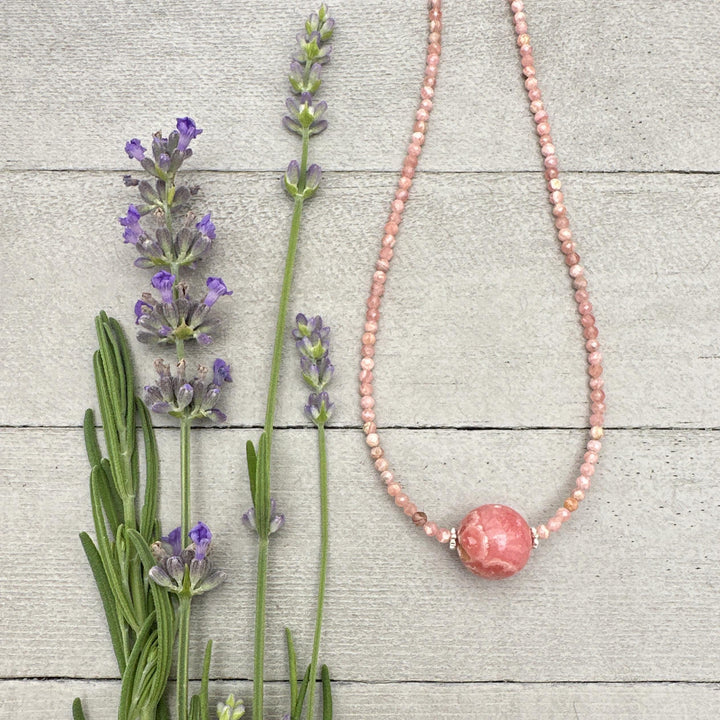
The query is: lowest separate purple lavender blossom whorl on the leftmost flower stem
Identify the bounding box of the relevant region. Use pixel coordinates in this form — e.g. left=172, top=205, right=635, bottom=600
left=149, top=522, right=227, bottom=595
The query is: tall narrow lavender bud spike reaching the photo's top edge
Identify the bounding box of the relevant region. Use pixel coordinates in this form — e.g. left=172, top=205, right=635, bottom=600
left=283, top=4, right=335, bottom=198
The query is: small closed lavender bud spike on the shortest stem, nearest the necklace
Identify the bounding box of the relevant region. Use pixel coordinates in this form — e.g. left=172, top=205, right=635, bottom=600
left=292, top=314, right=335, bottom=426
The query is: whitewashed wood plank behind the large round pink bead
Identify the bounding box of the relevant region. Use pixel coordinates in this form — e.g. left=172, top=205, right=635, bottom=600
left=0, top=429, right=720, bottom=682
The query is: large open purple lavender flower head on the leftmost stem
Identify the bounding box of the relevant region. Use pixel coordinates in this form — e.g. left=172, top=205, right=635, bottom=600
left=119, top=117, right=233, bottom=422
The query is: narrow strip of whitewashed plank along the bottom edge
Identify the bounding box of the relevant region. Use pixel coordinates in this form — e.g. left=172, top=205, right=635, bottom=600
left=5, top=680, right=720, bottom=720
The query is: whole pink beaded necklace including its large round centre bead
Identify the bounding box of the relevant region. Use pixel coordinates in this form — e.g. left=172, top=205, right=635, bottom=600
left=359, top=0, right=605, bottom=579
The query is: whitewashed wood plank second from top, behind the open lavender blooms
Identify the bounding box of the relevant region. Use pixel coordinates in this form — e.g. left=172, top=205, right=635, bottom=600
left=0, top=173, right=720, bottom=428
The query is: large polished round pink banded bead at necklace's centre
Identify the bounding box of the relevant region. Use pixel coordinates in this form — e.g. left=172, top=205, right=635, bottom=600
left=458, top=505, right=533, bottom=580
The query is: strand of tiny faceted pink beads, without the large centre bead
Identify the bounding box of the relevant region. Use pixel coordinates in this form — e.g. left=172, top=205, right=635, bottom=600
left=359, top=0, right=605, bottom=546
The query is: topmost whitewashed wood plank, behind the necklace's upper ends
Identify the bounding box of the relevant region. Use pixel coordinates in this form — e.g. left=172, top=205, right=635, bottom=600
left=0, top=0, right=720, bottom=171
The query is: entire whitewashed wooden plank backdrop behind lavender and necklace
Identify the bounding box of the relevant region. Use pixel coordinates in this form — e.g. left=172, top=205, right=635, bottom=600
left=0, top=0, right=720, bottom=720
